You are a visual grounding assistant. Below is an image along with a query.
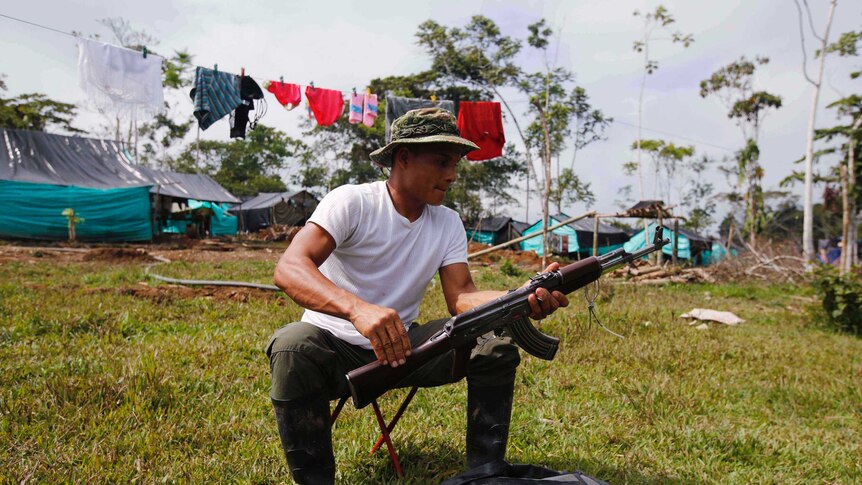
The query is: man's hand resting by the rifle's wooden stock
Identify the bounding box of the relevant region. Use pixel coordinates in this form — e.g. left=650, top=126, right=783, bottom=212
left=350, top=302, right=411, bottom=367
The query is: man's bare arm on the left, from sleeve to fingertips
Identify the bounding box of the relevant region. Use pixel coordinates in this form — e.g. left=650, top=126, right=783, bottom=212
left=273, top=223, right=410, bottom=367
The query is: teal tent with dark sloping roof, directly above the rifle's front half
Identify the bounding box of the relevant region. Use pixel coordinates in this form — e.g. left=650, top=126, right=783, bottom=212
left=521, top=213, right=628, bottom=256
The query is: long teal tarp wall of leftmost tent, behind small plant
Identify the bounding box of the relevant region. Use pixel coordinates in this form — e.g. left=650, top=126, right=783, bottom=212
left=0, top=180, right=152, bottom=241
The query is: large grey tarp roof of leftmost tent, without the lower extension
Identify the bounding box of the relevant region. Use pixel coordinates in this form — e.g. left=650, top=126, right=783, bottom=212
left=0, top=125, right=153, bottom=189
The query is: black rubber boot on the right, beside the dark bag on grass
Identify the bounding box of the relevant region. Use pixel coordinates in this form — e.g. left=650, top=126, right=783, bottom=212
left=467, top=381, right=515, bottom=468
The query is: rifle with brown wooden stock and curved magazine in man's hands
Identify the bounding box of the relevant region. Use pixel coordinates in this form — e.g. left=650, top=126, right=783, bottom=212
left=347, top=227, right=670, bottom=409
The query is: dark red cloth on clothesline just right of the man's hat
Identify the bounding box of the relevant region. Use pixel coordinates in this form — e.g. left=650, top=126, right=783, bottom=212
left=458, top=101, right=506, bottom=162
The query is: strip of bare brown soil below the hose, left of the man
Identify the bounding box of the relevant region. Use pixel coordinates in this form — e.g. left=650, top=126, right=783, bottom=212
left=104, top=283, right=286, bottom=303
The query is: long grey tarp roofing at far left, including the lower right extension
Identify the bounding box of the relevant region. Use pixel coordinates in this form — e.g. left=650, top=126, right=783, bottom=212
left=0, top=129, right=239, bottom=202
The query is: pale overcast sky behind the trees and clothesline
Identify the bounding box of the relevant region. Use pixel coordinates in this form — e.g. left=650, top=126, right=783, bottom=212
left=0, top=0, right=862, bottom=232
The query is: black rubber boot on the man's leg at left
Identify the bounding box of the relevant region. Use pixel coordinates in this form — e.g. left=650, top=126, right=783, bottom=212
left=272, top=396, right=335, bottom=485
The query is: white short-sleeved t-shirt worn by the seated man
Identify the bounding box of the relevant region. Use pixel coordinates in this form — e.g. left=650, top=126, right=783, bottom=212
left=302, top=182, right=467, bottom=349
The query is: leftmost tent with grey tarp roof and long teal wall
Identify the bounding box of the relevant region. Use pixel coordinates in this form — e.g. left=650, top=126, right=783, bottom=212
left=0, top=129, right=153, bottom=241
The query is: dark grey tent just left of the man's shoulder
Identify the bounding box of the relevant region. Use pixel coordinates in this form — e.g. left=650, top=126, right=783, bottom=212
left=231, top=190, right=319, bottom=232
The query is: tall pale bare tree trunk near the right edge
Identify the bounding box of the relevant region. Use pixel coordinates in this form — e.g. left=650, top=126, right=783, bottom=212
left=802, top=0, right=838, bottom=269
